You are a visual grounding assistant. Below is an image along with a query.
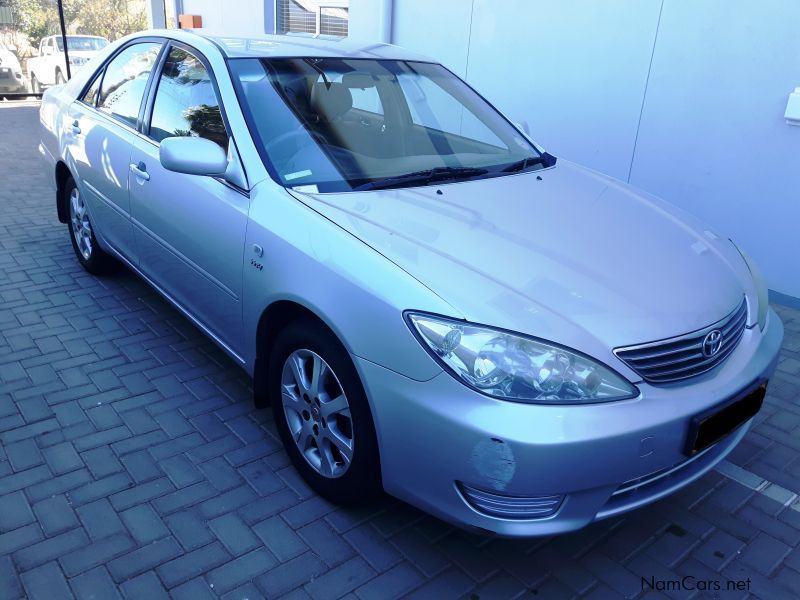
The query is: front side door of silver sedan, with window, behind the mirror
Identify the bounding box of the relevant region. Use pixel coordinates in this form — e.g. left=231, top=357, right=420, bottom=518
left=131, top=42, right=250, bottom=352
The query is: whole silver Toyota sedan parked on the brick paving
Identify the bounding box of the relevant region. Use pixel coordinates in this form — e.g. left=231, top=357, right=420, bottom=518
left=40, top=31, right=783, bottom=536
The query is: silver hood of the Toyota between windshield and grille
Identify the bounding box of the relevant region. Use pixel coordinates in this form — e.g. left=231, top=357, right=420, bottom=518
left=293, top=160, right=752, bottom=351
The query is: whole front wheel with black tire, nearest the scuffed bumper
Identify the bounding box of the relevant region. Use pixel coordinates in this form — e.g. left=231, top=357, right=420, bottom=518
left=268, top=319, right=382, bottom=504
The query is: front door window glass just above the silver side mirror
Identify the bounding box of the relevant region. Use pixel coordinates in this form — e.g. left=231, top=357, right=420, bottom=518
left=150, top=48, right=228, bottom=150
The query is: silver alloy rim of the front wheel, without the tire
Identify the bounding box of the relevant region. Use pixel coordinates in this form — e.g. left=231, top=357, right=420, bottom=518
left=281, top=350, right=354, bottom=479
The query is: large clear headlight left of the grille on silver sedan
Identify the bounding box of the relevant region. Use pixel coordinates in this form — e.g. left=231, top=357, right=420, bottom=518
left=406, top=313, right=639, bottom=404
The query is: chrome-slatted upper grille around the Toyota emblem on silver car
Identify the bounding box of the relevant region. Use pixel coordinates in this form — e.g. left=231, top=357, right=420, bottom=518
left=614, top=298, right=747, bottom=383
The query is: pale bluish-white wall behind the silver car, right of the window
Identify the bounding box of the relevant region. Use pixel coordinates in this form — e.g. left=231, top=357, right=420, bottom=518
left=350, top=0, right=800, bottom=297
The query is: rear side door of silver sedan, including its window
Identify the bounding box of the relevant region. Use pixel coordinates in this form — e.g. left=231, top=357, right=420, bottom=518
left=67, top=41, right=162, bottom=263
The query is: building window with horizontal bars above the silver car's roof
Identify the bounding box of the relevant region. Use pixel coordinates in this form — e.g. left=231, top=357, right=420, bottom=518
left=276, top=0, right=350, bottom=37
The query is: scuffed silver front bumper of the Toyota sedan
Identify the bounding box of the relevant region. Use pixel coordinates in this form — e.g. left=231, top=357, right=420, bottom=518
left=354, top=310, right=783, bottom=536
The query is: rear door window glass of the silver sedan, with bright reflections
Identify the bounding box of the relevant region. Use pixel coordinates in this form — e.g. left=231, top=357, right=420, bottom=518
left=97, top=42, right=161, bottom=127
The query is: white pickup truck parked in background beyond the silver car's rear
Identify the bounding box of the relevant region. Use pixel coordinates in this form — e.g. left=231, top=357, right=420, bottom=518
left=28, top=35, right=108, bottom=93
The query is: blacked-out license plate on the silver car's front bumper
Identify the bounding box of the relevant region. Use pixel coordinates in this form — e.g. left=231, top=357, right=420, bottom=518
left=685, top=381, right=767, bottom=456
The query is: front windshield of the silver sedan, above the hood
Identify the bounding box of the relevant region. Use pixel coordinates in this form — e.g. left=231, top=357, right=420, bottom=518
left=230, top=58, right=547, bottom=192
